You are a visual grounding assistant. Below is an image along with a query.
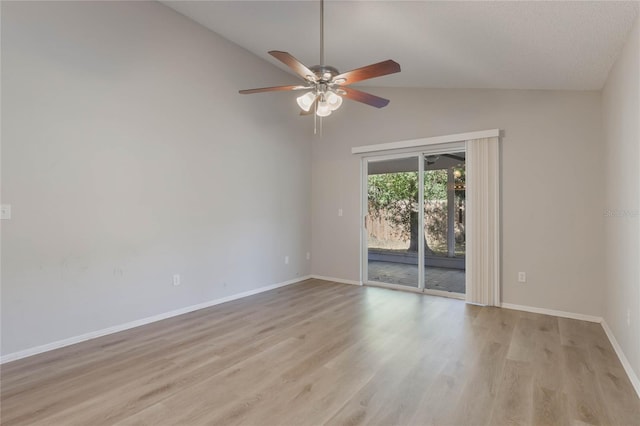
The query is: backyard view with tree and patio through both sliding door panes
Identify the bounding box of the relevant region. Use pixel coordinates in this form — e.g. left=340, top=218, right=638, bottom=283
left=366, top=153, right=465, bottom=293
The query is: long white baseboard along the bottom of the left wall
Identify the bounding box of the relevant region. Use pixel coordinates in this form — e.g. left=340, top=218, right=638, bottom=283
left=0, top=275, right=311, bottom=364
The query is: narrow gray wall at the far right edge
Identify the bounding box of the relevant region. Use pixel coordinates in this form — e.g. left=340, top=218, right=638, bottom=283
left=603, top=18, right=640, bottom=384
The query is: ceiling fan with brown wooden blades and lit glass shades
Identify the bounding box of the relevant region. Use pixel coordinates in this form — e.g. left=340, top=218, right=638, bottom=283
left=240, top=0, right=400, bottom=117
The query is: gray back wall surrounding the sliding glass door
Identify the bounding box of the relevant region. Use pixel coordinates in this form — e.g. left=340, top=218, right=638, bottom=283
left=311, top=88, right=604, bottom=316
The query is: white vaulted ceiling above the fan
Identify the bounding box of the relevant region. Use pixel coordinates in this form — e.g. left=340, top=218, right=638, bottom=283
left=163, top=0, right=639, bottom=90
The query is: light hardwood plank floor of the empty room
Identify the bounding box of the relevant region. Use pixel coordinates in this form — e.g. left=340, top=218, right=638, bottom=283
left=1, top=280, right=640, bottom=426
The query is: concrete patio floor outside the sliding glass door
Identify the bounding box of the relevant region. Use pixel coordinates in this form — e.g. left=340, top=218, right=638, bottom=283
left=369, top=260, right=465, bottom=294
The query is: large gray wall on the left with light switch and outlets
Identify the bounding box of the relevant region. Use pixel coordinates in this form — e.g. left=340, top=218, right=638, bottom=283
left=1, top=1, right=312, bottom=354
